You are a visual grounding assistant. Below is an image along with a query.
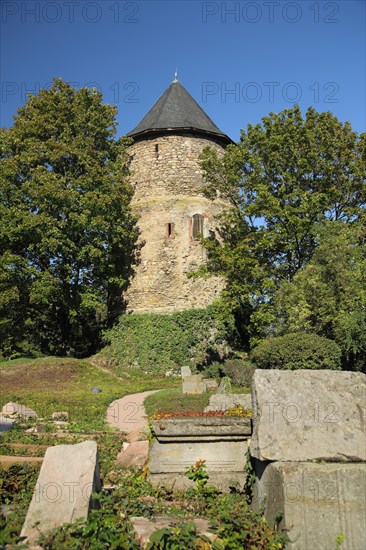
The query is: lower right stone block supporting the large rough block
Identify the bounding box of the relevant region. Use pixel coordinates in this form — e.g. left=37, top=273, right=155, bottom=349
left=254, top=461, right=366, bottom=550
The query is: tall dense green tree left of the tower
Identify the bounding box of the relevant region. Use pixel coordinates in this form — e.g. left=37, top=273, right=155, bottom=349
left=0, top=79, right=137, bottom=356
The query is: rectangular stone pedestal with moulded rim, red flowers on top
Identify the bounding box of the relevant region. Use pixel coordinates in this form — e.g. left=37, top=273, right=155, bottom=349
left=149, top=417, right=251, bottom=490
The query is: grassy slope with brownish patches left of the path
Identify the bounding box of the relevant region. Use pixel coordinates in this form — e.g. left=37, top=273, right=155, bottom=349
left=0, top=357, right=177, bottom=430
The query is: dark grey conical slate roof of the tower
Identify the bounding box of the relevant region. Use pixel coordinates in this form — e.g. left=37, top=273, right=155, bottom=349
left=127, top=80, right=231, bottom=143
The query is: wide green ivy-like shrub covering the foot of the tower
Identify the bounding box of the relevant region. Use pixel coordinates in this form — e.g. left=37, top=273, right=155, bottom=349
left=105, top=306, right=235, bottom=374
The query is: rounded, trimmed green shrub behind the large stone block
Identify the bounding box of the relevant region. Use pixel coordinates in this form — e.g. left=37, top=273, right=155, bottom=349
left=250, top=332, right=341, bottom=370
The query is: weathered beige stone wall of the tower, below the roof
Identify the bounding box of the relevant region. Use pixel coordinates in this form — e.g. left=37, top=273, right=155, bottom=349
left=126, top=135, right=227, bottom=313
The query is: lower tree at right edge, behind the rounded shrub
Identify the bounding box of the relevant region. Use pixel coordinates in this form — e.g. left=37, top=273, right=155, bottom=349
left=276, top=222, right=366, bottom=370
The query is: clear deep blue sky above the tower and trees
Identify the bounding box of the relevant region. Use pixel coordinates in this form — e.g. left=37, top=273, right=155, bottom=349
left=0, top=0, right=366, bottom=140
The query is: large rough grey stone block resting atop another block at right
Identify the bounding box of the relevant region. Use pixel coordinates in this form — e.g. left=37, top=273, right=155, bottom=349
left=250, top=370, right=366, bottom=462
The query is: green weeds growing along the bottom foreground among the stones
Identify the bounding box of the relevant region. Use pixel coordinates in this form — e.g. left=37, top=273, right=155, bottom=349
left=0, top=461, right=285, bottom=550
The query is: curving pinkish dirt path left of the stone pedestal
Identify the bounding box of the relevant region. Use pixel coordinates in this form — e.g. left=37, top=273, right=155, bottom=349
left=107, top=390, right=159, bottom=468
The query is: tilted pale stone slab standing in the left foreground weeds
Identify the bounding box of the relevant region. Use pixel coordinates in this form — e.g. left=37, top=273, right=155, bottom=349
left=20, top=441, right=101, bottom=545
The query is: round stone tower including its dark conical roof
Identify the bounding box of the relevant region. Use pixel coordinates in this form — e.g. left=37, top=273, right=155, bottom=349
left=126, top=80, right=231, bottom=313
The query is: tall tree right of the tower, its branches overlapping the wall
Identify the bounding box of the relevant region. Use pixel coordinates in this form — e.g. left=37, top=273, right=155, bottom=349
left=202, top=105, right=366, bottom=368
